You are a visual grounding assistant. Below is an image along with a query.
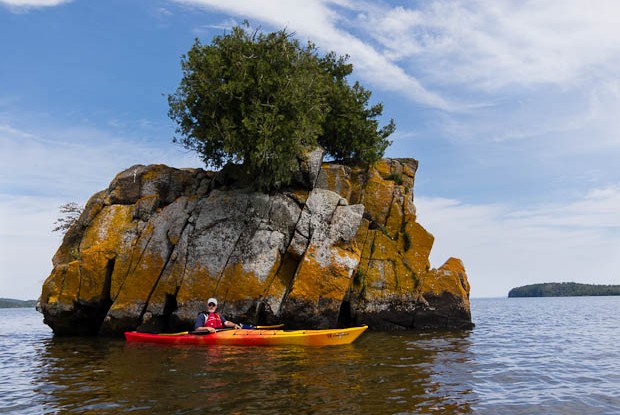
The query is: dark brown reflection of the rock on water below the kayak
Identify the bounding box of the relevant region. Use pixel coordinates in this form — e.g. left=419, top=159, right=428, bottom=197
left=25, top=333, right=475, bottom=414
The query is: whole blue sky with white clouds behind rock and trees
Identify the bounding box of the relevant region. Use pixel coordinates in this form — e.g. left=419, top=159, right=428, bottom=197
left=0, top=0, right=620, bottom=299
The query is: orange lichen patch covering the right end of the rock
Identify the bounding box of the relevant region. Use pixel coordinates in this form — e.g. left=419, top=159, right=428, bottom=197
left=344, top=160, right=468, bottom=308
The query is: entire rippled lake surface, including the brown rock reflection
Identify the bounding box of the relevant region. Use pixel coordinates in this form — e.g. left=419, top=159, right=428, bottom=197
left=13, top=297, right=620, bottom=415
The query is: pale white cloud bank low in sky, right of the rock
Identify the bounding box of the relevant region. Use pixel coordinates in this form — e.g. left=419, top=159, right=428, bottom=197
left=416, top=192, right=620, bottom=297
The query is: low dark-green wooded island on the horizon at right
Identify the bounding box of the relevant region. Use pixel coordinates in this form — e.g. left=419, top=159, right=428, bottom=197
left=508, top=282, right=620, bottom=297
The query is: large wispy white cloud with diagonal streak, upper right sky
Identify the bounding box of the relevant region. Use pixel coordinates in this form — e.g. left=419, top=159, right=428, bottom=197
left=168, top=0, right=620, bottom=148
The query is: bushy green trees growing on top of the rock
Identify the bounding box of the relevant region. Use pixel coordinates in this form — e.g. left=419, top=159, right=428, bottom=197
left=168, top=24, right=394, bottom=190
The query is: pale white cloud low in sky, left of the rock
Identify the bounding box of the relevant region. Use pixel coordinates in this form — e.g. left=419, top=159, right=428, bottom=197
left=0, top=118, right=201, bottom=299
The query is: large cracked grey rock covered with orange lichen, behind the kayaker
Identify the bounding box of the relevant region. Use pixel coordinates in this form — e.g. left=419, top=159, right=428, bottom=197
left=40, top=154, right=473, bottom=335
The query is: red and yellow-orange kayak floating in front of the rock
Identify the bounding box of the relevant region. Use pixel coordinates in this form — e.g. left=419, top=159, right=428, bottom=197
left=125, top=325, right=368, bottom=346
